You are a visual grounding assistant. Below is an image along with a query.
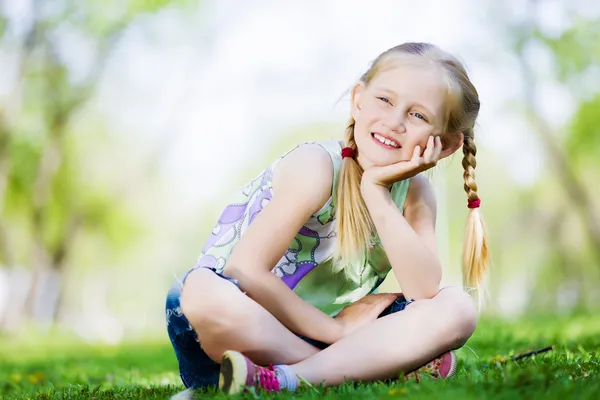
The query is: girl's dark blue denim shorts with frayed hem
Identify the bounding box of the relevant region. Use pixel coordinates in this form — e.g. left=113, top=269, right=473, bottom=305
left=165, top=267, right=414, bottom=389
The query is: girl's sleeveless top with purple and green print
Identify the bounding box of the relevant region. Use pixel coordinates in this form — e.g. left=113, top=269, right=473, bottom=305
left=195, top=140, right=409, bottom=317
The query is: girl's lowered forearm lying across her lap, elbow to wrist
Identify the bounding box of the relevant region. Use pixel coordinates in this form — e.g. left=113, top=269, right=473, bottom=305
left=230, top=270, right=343, bottom=344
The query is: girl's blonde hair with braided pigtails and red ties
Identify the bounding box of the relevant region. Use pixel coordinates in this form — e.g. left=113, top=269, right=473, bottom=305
left=333, top=43, right=489, bottom=300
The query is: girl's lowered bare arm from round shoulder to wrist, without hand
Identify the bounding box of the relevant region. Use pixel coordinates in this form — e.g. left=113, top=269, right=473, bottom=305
left=224, top=145, right=343, bottom=343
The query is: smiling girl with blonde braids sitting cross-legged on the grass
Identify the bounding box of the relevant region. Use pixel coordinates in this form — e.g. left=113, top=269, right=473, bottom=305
left=166, top=43, right=488, bottom=393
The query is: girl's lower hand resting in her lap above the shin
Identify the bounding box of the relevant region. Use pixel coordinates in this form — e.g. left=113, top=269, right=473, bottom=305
left=335, top=293, right=401, bottom=337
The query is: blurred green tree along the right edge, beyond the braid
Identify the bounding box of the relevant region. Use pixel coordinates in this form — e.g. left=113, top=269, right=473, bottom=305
left=502, top=0, right=600, bottom=307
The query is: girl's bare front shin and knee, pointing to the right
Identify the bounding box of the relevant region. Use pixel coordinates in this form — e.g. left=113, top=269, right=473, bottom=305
left=291, top=288, right=476, bottom=385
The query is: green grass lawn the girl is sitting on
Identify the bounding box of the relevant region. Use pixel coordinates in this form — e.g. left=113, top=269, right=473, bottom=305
left=0, top=315, right=600, bottom=400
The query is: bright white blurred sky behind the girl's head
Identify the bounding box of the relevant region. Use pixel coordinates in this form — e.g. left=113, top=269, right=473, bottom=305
left=101, top=0, right=568, bottom=216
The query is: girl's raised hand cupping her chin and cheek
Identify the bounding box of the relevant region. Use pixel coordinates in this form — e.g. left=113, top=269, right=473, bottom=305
left=361, top=136, right=442, bottom=189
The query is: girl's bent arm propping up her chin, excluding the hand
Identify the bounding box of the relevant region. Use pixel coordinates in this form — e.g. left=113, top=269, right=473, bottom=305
left=362, top=175, right=442, bottom=299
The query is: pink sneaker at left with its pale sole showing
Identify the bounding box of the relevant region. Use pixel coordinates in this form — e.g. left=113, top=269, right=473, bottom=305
left=219, top=350, right=279, bottom=394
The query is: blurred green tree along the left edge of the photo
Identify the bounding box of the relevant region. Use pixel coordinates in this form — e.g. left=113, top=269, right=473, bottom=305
left=0, top=0, right=191, bottom=329
